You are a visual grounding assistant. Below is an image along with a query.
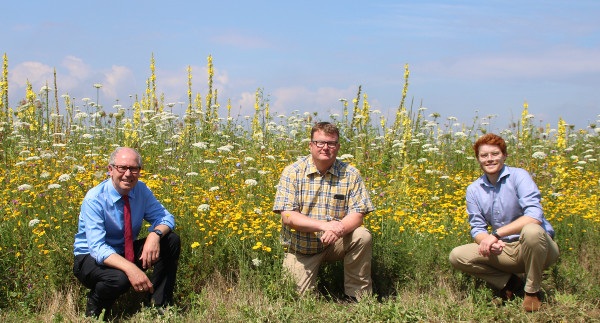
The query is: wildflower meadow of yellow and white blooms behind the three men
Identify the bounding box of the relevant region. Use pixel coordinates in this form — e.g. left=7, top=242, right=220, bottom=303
left=0, top=54, right=600, bottom=322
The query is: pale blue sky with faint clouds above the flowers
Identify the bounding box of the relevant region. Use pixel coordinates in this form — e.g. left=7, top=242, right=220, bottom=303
left=0, top=0, right=600, bottom=129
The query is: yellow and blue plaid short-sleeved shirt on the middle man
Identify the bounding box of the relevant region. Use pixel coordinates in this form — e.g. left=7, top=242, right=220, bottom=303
left=273, top=155, right=374, bottom=254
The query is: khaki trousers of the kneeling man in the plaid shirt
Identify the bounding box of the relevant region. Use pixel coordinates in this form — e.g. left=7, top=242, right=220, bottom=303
left=283, top=227, right=373, bottom=298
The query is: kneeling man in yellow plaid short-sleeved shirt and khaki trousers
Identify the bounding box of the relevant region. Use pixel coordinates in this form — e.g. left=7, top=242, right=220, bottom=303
left=273, top=122, right=374, bottom=300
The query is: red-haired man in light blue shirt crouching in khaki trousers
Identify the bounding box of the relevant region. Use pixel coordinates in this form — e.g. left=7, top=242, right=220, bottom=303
left=450, top=134, right=559, bottom=312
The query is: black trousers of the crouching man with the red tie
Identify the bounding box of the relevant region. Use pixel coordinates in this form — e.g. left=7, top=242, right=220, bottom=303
left=73, top=232, right=181, bottom=309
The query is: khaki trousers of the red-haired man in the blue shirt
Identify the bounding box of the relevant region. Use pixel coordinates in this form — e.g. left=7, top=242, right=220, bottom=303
left=450, top=223, right=559, bottom=293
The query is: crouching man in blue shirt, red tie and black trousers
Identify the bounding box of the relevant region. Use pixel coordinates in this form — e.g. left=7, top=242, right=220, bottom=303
left=73, top=147, right=181, bottom=317
